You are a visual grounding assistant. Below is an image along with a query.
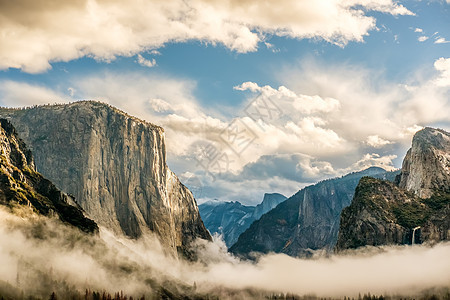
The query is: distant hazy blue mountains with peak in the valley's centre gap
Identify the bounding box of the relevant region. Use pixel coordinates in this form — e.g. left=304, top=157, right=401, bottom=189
left=199, top=193, right=287, bottom=247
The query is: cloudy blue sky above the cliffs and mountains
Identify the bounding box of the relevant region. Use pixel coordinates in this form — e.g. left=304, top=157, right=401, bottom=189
left=0, top=0, right=450, bottom=205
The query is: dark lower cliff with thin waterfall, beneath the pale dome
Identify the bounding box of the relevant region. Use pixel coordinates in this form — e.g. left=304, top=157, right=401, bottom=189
left=336, top=177, right=450, bottom=251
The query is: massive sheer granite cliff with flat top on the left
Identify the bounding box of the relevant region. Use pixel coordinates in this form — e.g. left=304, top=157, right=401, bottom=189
left=0, top=101, right=211, bottom=252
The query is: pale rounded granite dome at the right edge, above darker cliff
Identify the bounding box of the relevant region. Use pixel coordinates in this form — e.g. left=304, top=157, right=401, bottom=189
left=398, top=127, right=450, bottom=198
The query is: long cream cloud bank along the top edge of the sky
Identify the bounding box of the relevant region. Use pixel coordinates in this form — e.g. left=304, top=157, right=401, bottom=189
left=0, top=0, right=412, bottom=73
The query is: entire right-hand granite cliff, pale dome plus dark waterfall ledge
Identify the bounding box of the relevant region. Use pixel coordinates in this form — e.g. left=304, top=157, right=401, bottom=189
left=336, top=128, right=450, bottom=251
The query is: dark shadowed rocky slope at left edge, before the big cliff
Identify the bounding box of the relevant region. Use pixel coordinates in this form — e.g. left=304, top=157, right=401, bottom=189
left=0, top=119, right=98, bottom=233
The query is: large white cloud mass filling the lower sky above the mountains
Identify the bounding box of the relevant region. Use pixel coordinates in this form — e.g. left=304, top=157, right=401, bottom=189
left=0, top=54, right=450, bottom=203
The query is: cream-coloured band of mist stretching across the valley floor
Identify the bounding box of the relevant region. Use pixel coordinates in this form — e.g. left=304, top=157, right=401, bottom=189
left=0, top=208, right=450, bottom=299
